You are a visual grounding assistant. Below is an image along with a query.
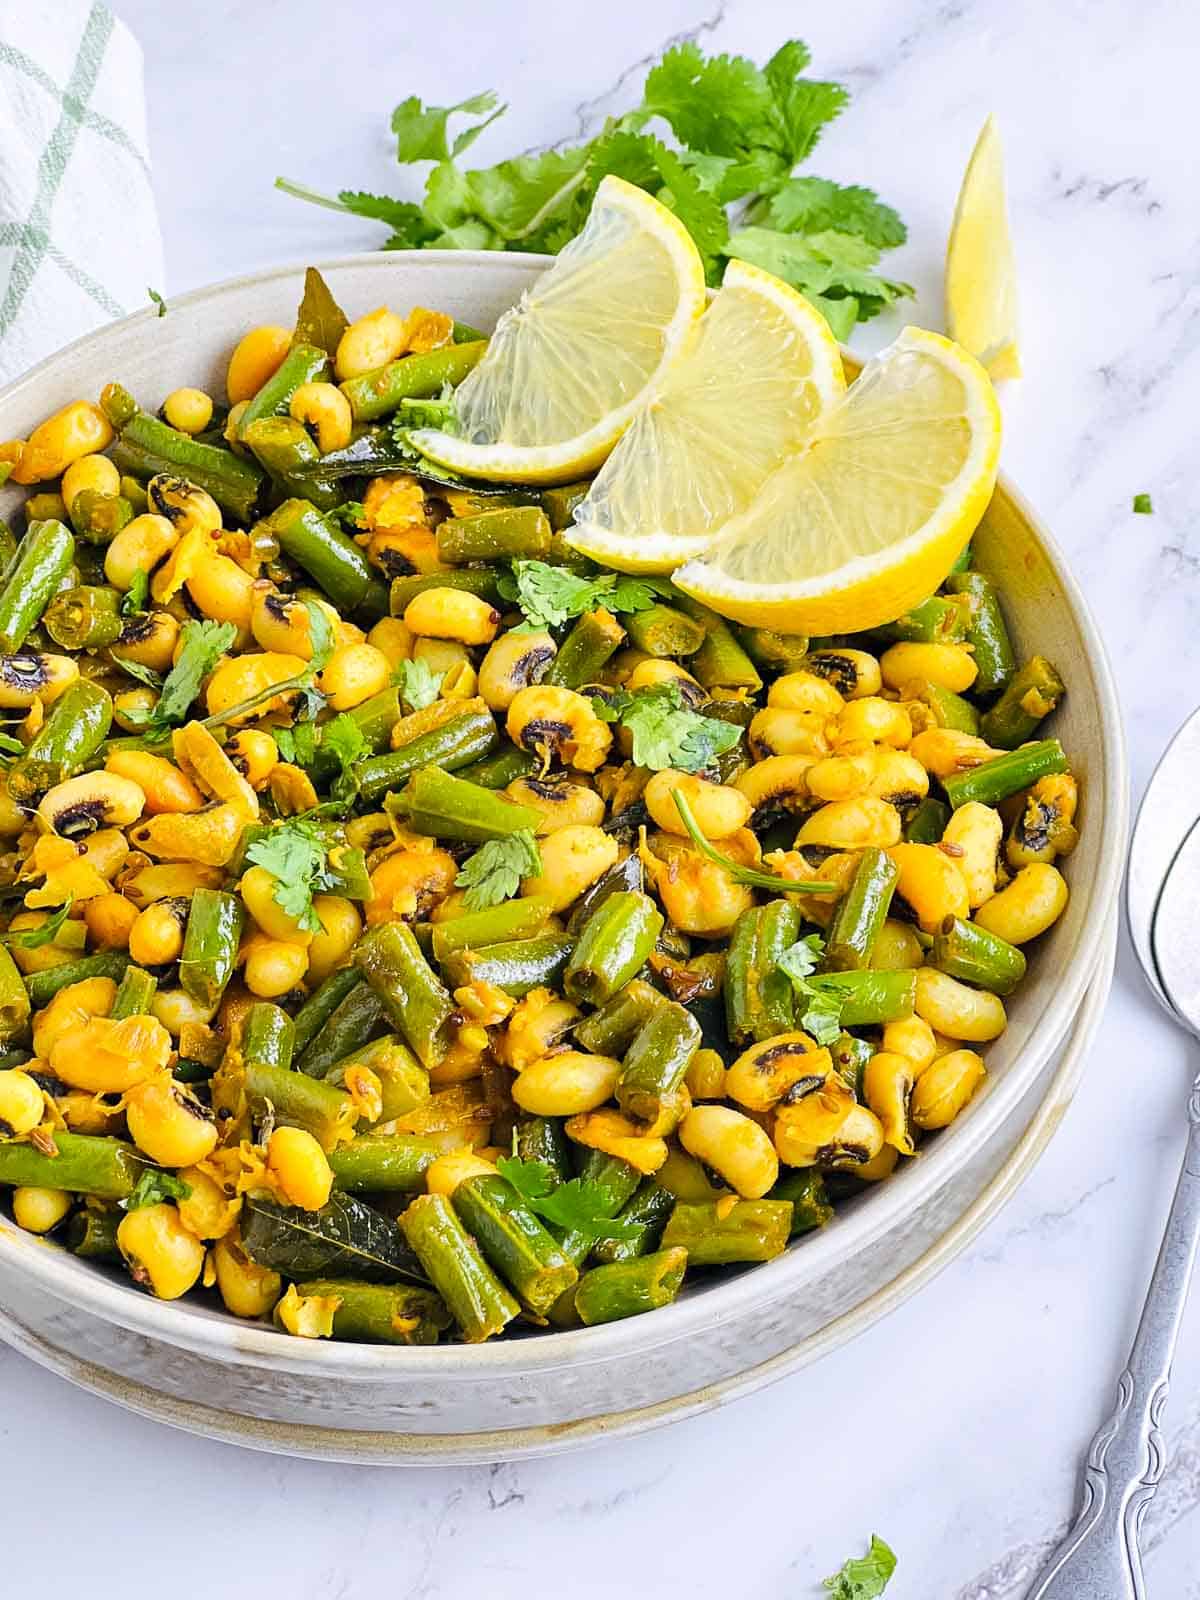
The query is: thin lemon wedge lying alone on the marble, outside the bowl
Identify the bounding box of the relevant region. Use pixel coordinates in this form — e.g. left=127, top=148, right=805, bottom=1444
left=946, top=117, right=1021, bottom=378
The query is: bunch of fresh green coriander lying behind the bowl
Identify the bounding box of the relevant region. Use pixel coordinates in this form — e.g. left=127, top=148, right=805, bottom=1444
left=275, top=38, right=912, bottom=338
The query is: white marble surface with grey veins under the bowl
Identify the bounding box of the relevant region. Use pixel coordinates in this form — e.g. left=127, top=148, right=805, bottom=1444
left=0, top=0, right=1200, bottom=1600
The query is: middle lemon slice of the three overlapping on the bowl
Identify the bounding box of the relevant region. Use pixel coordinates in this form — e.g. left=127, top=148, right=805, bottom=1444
left=566, top=261, right=846, bottom=573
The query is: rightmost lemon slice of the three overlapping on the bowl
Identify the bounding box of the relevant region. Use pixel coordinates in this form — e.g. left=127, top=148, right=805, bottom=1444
left=674, top=328, right=1000, bottom=634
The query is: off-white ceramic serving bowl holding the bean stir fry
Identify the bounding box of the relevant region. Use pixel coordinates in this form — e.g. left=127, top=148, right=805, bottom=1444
left=0, top=251, right=1128, bottom=1462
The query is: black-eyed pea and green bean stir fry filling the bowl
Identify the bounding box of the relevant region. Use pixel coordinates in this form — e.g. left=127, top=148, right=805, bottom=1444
left=0, top=184, right=1077, bottom=1344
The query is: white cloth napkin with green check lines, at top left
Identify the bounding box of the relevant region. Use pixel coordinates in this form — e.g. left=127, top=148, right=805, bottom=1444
left=0, top=0, right=163, bottom=384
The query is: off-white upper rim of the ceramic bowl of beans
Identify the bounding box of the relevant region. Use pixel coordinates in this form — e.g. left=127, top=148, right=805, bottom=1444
left=0, top=250, right=1130, bottom=1381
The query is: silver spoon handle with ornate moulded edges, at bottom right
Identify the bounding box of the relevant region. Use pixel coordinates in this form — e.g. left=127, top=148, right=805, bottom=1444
left=1027, top=1077, right=1200, bottom=1600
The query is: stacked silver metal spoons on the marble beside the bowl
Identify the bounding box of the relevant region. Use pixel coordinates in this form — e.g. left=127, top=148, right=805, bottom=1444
left=1029, top=768, right=1200, bottom=1600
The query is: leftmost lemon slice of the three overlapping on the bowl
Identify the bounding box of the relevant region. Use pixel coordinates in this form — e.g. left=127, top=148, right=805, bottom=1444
left=411, top=178, right=704, bottom=483
